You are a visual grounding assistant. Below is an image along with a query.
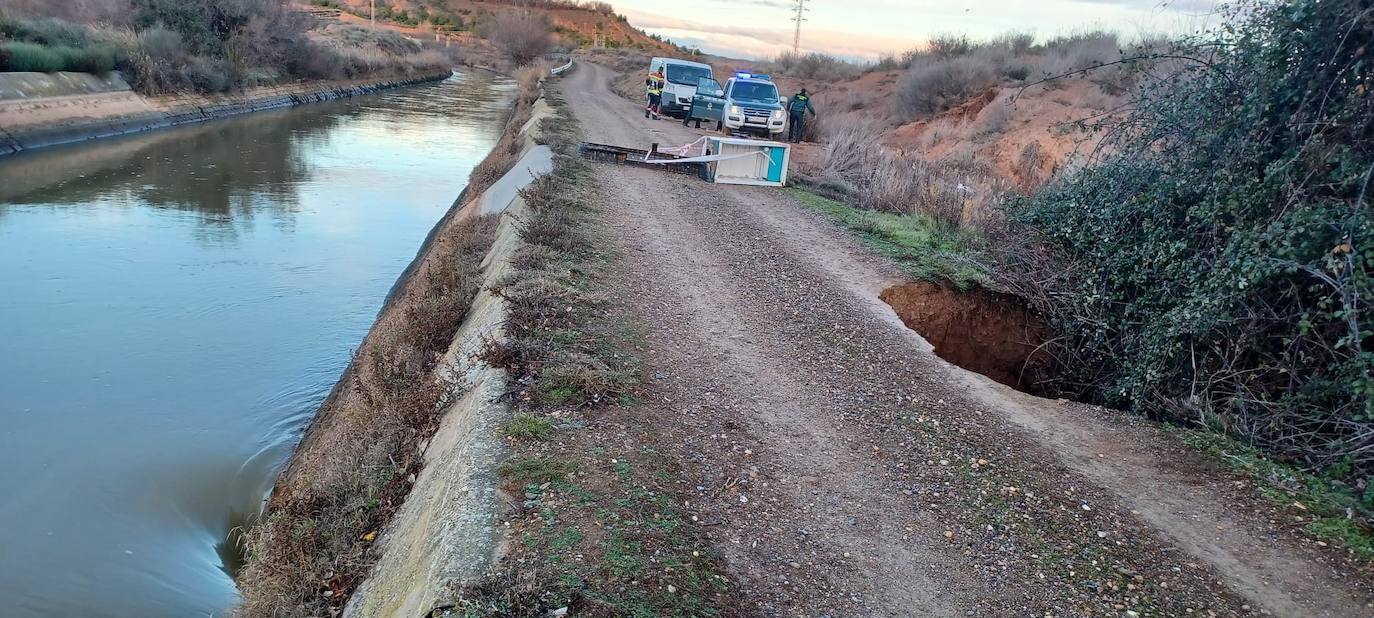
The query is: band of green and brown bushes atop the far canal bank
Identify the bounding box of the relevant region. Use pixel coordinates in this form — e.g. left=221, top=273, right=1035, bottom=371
left=8, top=0, right=448, bottom=95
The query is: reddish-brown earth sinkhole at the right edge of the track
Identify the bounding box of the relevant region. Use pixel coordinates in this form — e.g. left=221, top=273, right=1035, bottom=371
left=879, top=282, right=1054, bottom=393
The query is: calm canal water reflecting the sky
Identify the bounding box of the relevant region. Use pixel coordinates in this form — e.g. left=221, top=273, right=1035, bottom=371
left=0, top=73, right=514, bottom=617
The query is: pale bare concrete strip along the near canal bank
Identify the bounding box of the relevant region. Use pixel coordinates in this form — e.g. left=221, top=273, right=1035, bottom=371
left=344, top=99, right=552, bottom=617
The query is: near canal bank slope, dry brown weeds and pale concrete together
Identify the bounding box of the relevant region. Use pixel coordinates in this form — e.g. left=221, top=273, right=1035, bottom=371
left=238, top=68, right=550, bottom=617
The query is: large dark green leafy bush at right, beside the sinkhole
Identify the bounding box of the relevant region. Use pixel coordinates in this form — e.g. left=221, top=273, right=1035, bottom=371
left=1014, top=0, right=1374, bottom=477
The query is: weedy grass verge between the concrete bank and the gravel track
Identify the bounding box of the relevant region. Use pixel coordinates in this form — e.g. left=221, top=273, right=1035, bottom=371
left=453, top=89, right=732, bottom=618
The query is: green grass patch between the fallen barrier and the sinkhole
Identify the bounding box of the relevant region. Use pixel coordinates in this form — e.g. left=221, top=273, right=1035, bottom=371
left=787, top=187, right=991, bottom=290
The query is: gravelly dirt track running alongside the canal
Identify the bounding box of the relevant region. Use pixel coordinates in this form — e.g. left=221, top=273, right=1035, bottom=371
left=559, top=63, right=1374, bottom=617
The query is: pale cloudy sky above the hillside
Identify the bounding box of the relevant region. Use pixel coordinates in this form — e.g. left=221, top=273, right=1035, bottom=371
left=613, top=0, right=1217, bottom=59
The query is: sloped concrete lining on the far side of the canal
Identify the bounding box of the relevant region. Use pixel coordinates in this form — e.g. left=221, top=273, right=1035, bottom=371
left=0, top=71, right=452, bottom=157
